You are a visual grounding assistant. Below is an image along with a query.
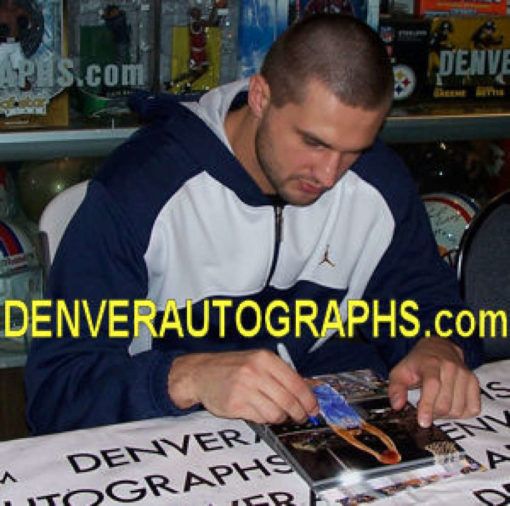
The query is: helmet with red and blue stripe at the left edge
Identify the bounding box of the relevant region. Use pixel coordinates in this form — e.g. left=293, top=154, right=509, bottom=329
left=0, top=220, right=43, bottom=335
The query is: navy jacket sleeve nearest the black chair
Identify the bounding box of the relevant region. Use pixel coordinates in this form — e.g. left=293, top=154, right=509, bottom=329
left=354, top=148, right=482, bottom=368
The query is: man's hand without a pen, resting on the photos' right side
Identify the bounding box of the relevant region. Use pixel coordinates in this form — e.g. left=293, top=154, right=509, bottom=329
left=388, top=337, right=480, bottom=427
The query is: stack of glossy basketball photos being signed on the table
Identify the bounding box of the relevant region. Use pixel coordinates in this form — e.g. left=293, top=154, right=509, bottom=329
left=249, top=369, right=476, bottom=504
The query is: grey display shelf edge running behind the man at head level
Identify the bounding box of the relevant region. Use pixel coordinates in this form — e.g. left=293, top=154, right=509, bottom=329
left=0, top=105, right=510, bottom=162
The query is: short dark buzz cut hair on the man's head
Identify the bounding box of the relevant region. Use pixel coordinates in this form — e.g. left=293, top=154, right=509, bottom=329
left=260, top=14, right=393, bottom=110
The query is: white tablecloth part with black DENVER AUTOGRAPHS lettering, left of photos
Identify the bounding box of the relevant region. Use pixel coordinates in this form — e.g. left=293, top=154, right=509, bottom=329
left=0, top=413, right=308, bottom=506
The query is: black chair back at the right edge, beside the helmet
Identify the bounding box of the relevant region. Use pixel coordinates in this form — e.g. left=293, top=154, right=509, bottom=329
left=457, top=190, right=510, bottom=361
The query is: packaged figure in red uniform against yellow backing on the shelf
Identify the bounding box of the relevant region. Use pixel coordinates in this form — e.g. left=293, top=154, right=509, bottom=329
left=160, top=0, right=239, bottom=93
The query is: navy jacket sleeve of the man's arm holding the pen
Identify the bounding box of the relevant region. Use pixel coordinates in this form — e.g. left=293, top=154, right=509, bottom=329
left=25, top=181, right=198, bottom=434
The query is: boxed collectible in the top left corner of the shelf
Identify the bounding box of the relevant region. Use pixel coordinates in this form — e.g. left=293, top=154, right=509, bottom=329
left=0, top=0, right=69, bottom=129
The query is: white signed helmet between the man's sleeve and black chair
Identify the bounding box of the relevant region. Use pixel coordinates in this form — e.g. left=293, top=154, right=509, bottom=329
left=422, top=192, right=479, bottom=267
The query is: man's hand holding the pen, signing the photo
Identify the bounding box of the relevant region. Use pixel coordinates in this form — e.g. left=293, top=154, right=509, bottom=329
left=168, top=350, right=319, bottom=423
